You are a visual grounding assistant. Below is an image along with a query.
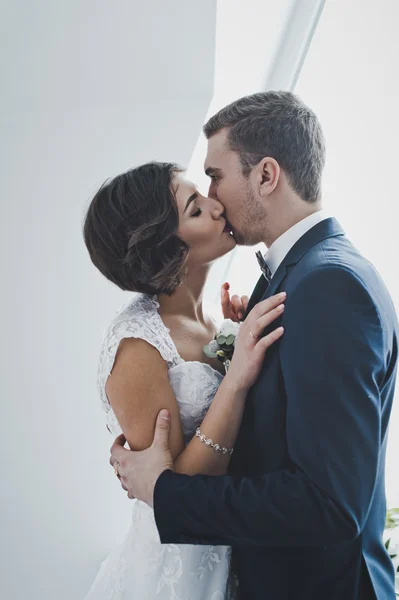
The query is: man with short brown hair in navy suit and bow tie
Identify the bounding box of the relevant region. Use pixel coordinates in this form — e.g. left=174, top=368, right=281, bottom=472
left=111, top=92, right=398, bottom=600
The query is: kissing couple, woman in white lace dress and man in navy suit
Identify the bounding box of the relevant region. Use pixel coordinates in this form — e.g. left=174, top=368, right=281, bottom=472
left=84, top=91, right=398, bottom=600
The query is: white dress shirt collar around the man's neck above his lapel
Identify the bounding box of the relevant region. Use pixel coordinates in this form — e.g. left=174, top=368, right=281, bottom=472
left=265, top=209, right=331, bottom=277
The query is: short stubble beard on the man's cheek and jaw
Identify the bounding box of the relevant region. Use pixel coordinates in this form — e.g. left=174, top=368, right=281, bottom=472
left=234, top=181, right=268, bottom=246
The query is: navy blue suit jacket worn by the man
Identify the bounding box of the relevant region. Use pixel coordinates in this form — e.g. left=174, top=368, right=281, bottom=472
left=154, top=219, right=398, bottom=600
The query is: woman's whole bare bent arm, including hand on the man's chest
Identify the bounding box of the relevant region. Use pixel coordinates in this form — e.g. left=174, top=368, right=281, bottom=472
left=106, top=296, right=283, bottom=475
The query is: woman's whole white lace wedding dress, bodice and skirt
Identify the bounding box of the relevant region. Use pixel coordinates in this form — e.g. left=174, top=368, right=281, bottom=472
left=86, top=294, right=237, bottom=600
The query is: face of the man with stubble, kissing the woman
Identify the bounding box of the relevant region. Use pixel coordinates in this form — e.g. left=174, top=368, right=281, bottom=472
left=204, top=128, right=265, bottom=246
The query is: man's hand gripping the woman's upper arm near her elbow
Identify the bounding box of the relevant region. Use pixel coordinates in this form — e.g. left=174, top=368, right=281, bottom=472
left=110, top=410, right=173, bottom=506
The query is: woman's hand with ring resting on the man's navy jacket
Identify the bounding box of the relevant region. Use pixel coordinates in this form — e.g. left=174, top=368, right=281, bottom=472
left=226, top=292, right=286, bottom=391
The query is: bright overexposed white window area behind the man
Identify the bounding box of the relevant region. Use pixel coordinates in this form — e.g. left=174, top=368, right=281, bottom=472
left=191, top=0, right=399, bottom=506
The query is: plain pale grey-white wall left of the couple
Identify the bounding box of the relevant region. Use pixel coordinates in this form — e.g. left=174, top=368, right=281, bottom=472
left=0, top=0, right=216, bottom=600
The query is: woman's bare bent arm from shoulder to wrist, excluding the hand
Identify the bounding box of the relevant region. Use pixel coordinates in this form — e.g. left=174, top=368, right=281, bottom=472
left=106, top=339, right=241, bottom=475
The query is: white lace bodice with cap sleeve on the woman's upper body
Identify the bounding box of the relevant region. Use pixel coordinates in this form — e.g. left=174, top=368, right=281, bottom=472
left=98, top=294, right=223, bottom=444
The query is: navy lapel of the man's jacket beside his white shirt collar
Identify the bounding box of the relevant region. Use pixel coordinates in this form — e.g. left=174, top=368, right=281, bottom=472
left=245, top=218, right=345, bottom=316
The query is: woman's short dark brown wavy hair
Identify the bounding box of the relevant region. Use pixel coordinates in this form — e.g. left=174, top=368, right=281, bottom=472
left=83, top=162, right=188, bottom=294
